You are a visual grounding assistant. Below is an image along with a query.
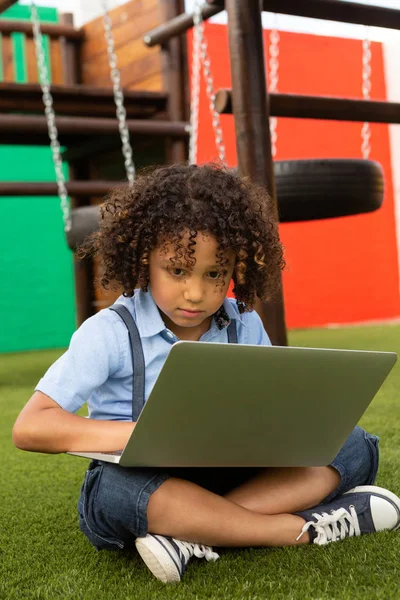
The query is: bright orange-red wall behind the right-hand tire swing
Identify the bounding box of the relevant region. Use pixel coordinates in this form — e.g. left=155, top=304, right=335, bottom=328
left=188, top=23, right=400, bottom=328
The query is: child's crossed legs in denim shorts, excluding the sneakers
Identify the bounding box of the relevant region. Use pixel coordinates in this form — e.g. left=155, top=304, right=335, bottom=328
left=79, top=428, right=378, bottom=549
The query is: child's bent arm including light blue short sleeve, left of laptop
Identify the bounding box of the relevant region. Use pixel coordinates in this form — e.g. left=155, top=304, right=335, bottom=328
left=13, top=311, right=135, bottom=453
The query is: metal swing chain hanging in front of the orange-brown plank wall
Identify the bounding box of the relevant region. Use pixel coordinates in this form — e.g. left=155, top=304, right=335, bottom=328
left=102, top=0, right=135, bottom=185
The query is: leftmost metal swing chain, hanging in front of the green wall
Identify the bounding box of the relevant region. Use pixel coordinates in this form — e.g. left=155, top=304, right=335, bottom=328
left=31, top=2, right=71, bottom=231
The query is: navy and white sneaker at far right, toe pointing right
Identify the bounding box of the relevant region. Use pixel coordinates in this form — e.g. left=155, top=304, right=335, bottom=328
left=296, top=485, right=400, bottom=546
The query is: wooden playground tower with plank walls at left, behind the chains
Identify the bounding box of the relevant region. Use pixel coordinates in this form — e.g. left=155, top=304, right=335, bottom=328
left=0, top=0, right=189, bottom=323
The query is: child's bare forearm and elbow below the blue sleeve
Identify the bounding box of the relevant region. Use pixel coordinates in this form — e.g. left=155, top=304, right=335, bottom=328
left=13, top=392, right=136, bottom=453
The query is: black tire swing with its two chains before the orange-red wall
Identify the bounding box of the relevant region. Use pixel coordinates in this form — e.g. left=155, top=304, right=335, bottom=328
left=269, top=21, right=384, bottom=223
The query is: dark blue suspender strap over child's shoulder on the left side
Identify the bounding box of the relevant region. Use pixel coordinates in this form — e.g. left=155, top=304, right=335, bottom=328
left=110, top=304, right=145, bottom=421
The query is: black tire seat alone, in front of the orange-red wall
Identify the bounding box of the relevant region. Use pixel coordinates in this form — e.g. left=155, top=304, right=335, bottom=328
left=274, top=159, right=384, bottom=223
